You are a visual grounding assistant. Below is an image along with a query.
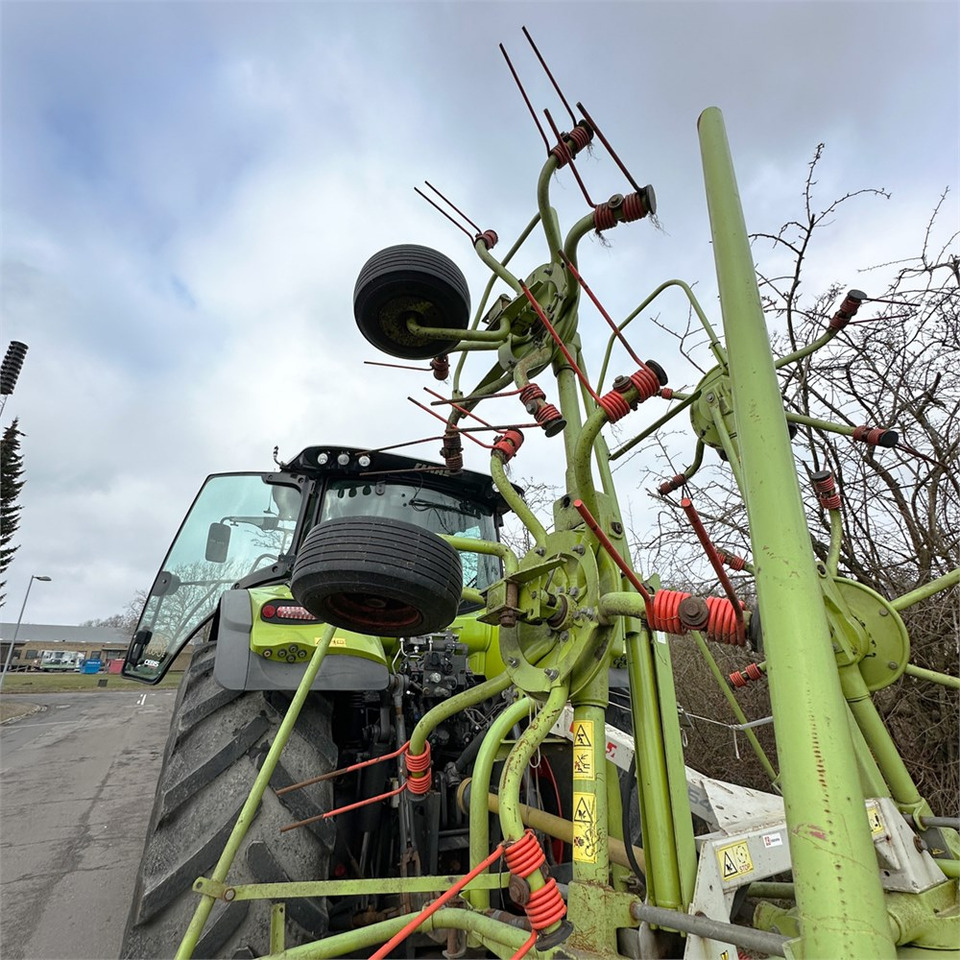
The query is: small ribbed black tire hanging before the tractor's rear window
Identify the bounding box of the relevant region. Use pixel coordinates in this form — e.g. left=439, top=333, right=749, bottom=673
left=290, top=517, right=463, bottom=637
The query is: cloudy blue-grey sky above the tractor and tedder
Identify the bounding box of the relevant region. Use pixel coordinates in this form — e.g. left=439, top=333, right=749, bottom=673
left=0, top=0, right=960, bottom=624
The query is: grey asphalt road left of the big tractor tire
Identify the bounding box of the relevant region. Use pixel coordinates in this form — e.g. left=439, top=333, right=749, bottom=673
left=0, top=689, right=176, bottom=960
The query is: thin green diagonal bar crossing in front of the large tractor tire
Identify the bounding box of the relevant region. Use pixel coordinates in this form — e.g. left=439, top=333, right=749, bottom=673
left=176, top=626, right=337, bottom=960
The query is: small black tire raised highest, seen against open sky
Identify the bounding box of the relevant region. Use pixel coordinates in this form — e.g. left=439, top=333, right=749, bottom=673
left=353, top=243, right=470, bottom=360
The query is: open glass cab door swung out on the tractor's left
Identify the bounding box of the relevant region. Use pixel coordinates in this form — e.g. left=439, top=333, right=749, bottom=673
left=124, top=473, right=301, bottom=680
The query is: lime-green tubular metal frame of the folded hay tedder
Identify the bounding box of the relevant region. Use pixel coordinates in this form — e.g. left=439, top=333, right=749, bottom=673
left=177, top=97, right=960, bottom=960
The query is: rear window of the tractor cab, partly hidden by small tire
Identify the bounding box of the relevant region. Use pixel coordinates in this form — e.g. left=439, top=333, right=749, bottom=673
left=319, top=479, right=500, bottom=590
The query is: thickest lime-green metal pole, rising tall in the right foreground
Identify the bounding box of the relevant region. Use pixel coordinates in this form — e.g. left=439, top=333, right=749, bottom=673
left=692, top=107, right=896, bottom=960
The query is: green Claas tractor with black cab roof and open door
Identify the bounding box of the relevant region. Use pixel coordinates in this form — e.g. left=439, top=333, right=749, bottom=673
left=124, top=446, right=532, bottom=957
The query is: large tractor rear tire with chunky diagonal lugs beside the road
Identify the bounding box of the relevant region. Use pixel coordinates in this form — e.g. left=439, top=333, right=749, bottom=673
left=121, top=644, right=337, bottom=958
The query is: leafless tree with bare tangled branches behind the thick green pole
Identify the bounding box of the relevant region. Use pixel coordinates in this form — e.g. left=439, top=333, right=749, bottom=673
left=635, top=145, right=960, bottom=814
